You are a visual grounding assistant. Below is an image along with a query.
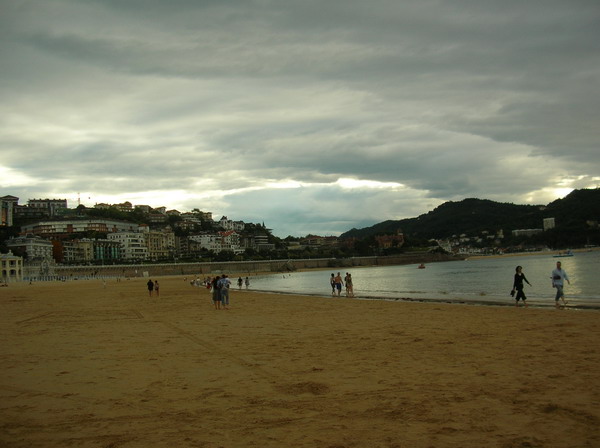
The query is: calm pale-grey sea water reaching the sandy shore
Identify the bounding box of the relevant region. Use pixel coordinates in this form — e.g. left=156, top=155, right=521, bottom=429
left=251, top=251, right=600, bottom=308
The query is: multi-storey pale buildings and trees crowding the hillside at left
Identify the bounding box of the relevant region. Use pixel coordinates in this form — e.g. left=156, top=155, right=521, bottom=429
left=0, top=192, right=403, bottom=264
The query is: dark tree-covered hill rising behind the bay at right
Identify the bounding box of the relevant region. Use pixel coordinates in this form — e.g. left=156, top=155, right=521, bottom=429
left=340, top=188, right=600, bottom=239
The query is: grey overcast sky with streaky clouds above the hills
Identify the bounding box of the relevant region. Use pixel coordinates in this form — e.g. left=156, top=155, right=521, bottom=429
left=0, top=0, right=600, bottom=237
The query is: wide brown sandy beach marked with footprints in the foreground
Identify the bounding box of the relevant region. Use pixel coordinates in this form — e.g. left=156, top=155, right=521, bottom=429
left=0, top=278, right=600, bottom=448
